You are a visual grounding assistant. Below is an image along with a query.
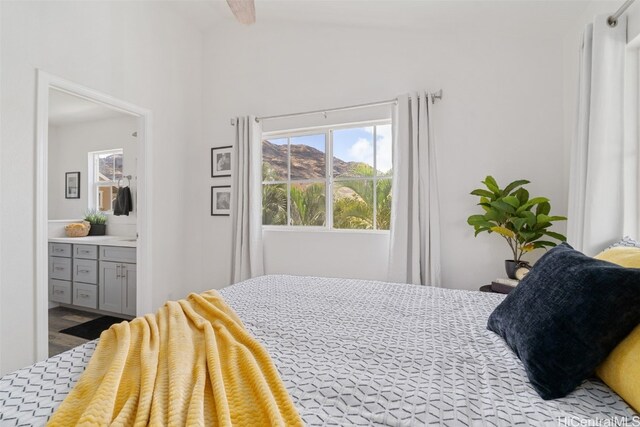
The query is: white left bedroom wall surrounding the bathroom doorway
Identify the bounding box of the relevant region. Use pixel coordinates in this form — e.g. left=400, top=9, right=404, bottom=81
left=0, top=1, right=202, bottom=374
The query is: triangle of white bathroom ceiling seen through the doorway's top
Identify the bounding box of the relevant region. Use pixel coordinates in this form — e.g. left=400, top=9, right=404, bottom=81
left=49, top=89, right=125, bottom=126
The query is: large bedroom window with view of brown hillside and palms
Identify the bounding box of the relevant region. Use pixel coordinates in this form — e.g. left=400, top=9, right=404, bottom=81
left=262, top=122, right=393, bottom=230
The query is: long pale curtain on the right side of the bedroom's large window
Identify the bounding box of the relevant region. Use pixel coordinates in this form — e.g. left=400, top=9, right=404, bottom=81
left=389, top=92, right=440, bottom=286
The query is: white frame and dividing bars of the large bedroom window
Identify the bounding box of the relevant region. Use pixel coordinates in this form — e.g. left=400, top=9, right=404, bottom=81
left=260, top=118, right=393, bottom=234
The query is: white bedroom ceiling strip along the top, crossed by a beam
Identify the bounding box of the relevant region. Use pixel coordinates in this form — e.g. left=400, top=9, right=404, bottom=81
left=166, top=0, right=600, bottom=32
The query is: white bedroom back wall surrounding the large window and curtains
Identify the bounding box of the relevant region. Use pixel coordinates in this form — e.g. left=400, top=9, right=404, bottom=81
left=189, top=20, right=566, bottom=289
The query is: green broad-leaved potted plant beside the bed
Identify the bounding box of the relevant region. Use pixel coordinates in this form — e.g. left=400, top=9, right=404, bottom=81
left=467, top=176, right=567, bottom=279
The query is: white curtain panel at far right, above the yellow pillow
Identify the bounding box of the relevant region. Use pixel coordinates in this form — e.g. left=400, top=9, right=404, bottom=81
left=567, top=15, right=637, bottom=255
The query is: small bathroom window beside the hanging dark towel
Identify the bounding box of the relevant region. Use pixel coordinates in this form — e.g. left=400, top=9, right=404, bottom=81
left=88, top=148, right=123, bottom=212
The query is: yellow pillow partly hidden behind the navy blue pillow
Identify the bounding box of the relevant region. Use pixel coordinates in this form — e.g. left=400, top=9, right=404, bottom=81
left=595, top=247, right=640, bottom=412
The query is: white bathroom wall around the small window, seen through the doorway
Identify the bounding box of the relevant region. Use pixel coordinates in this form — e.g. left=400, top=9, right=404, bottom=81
left=48, top=113, right=138, bottom=236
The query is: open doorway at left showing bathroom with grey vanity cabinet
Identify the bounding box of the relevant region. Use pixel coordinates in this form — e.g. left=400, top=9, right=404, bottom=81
left=36, top=71, right=151, bottom=360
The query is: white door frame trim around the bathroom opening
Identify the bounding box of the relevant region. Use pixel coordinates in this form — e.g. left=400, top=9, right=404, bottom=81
left=35, top=69, right=153, bottom=360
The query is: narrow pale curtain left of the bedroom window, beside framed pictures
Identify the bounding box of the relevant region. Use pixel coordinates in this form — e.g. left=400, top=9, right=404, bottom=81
left=231, top=116, right=264, bottom=283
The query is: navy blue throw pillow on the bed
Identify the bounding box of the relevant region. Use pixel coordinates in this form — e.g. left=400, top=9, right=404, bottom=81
left=487, top=243, right=640, bottom=400
